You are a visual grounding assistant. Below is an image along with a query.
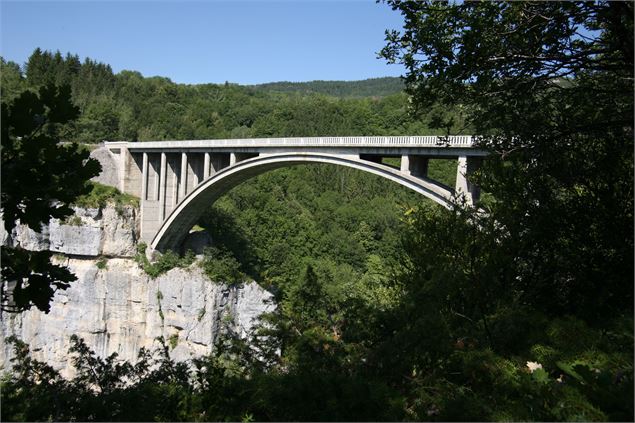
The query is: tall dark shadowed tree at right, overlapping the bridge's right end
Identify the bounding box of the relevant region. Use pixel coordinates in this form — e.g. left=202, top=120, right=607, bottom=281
left=382, top=0, right=634, bottom=319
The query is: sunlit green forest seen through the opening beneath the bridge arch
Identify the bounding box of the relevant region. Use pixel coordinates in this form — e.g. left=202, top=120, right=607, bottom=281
left=199, top=160, right=456, bottom=290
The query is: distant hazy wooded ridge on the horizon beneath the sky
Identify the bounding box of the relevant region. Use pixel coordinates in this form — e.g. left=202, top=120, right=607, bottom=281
left=249, top=76, right=404, bottom=98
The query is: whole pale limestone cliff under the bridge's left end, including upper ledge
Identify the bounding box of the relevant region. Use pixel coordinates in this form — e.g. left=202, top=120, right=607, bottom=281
left=0, top=207, right=275, bottom=377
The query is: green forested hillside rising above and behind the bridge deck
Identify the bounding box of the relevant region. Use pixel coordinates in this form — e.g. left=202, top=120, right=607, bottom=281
left=1, top=49, right=459, bottom=143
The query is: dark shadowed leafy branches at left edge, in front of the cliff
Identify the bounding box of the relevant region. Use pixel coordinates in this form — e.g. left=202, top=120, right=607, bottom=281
left=1, top=85, right=101, bottom=312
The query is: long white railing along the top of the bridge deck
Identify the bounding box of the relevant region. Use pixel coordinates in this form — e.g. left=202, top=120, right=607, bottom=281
left=113, top=135, right=472, bottom=149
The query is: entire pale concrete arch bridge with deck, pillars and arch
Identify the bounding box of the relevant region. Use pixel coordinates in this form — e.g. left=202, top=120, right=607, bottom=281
left=105, top=136, right=486, bottom=251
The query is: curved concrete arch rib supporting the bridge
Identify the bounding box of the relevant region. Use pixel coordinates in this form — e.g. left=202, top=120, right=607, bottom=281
left=150, top=153, right=454, bottom=251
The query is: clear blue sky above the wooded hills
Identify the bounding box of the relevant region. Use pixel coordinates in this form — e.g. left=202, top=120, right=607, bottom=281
left=0, top=0, right=404, bottom=84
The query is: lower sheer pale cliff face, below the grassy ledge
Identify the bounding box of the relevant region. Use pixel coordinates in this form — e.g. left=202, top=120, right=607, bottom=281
left=0, top=258, right=274, bottom=376
